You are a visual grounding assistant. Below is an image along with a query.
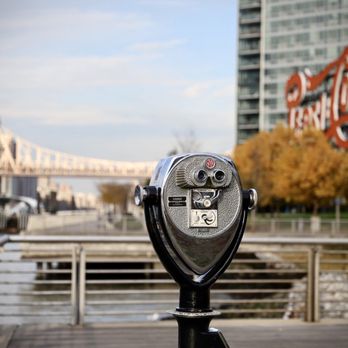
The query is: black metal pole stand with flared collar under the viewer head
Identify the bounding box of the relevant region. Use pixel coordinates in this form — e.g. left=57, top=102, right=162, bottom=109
left=170, top=287, right=229, bottom=348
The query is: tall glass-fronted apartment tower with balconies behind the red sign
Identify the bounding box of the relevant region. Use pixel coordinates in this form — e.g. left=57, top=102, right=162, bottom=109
left=237, top=0, right=348, bottom=143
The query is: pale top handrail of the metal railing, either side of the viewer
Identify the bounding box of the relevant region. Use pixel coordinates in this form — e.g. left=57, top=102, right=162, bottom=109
left=0, top=235, right=348, bottom=246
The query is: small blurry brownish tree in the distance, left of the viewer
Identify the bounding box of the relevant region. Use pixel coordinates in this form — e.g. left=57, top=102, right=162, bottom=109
left=98, top=182, right=130, bottom=213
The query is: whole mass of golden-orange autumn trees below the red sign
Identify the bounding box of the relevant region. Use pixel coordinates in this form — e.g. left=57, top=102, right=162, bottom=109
left=234, top=126, right=348, bottom=213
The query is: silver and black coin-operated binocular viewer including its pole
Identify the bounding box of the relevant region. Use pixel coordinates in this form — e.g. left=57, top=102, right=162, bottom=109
left=135, top=153, right=257, bottom=348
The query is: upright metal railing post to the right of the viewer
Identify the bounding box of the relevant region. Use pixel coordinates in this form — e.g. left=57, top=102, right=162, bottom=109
left=305, top=247, right=320, bottom=322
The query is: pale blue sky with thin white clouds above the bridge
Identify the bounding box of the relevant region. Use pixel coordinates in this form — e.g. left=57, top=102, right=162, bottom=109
left=0, top=0, right=237, bottom=190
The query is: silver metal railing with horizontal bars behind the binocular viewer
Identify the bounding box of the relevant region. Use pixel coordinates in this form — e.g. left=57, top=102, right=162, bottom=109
left=0, top=236, right=348, bottom=325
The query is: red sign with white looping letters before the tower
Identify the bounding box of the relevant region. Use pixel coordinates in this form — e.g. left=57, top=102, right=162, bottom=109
left=285, top=47, right=348, bottom=148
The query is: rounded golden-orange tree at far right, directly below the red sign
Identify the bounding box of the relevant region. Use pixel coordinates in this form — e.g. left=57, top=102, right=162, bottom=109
left=274, top=129, right=343, bottom=214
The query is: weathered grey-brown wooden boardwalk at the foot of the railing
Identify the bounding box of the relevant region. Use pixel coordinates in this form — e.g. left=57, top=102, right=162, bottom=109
left=0, top=320, right=348, bottom=348
